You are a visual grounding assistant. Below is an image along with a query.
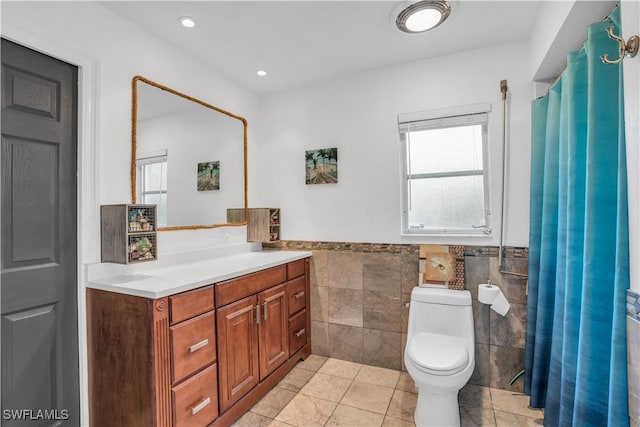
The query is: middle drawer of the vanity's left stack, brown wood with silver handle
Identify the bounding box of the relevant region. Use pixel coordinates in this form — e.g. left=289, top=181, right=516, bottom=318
left=169, top=311, right=216, bottom=384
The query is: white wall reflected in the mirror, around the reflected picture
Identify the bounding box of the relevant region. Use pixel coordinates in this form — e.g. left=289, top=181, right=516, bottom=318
left=137, top=108, right=244, bottom=226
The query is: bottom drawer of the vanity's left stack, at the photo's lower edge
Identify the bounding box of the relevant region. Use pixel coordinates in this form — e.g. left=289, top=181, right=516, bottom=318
left=171, top=364, right=218, bottom=427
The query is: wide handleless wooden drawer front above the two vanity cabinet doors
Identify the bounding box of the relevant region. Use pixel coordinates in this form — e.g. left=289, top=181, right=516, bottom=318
left=216, top=265, right=287, bottom=307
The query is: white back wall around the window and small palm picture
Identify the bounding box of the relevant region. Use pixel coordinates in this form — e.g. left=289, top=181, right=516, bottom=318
left=249, top=43, right=531, bottom=246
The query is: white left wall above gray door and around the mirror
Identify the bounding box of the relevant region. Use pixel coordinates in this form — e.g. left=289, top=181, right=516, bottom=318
left=2, top=2, right=257, bottom=256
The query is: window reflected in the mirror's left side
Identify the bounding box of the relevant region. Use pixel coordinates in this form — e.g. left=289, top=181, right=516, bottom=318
left=136, top=150, right=167, bottom=227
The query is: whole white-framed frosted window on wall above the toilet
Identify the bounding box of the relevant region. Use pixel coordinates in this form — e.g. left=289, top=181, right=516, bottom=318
left=399, top=105, right=491, bottom=235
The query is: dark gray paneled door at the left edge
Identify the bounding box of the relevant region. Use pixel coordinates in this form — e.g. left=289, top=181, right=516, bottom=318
left=0, top=39, right=80, bottom=426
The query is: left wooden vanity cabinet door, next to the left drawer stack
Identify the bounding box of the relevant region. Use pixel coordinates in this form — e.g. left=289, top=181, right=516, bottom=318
left=216, top=295, right=259, bottom=411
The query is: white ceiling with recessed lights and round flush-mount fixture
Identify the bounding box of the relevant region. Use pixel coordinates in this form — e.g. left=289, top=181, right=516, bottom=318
left=101, top=0, right=542, bottom=93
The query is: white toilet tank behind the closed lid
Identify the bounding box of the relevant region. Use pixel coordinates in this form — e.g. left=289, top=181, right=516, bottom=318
left=407, top=287, right=474, bottom=343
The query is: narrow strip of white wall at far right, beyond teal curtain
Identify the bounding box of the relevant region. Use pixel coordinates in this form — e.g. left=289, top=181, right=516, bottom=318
left=621, top=0, right=640, bottom=292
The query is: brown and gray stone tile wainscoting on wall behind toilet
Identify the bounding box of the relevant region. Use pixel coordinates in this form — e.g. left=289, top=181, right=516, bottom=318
left=264, top=241, right=528, bottom=392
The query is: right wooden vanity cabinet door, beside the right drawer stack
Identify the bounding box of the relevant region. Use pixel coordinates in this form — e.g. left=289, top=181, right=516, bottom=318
left=258, top=283, right=289, bottom=379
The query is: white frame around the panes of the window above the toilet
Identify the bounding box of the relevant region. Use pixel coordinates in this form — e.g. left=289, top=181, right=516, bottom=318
left=398, top=104, right=492, bottom=237
